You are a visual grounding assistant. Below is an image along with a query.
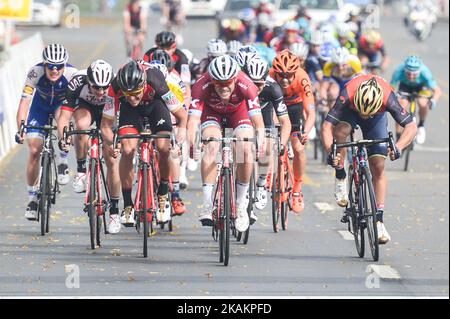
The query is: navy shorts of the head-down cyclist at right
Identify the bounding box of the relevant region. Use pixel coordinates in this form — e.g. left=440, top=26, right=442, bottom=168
left=341, top=109, right=389, bottom=158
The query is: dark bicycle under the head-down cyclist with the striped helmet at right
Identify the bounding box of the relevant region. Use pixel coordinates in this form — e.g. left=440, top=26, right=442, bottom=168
left=332, top=130, right=399, bottom=261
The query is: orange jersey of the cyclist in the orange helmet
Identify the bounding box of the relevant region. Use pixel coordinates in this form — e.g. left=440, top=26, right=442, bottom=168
left=270, top=69, right=314, bottom=109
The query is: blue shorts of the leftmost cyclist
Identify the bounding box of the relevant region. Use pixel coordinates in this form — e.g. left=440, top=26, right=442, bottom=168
left=27, top=94, right=61, bottom=139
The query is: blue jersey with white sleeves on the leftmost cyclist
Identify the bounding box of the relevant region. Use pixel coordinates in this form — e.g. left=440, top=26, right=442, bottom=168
left=22, top=63, right=77, bottom=107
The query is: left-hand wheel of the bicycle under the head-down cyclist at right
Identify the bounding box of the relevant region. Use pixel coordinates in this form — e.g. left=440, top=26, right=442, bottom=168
left=348, top=165, right=365, bottom=258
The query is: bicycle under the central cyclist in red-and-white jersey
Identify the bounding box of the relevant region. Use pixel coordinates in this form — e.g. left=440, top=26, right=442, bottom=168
left=201, top=137, right=256, bottom=266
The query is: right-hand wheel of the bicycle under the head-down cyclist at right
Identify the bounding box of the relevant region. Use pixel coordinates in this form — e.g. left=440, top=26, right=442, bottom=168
left=362, top=167, right=380, bottom=261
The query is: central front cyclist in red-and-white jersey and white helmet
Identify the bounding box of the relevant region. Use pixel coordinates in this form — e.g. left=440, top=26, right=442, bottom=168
left=188, top=55, right=264, bottom=232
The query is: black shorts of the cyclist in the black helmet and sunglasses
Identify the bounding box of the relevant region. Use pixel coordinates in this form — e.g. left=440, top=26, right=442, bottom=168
left=119, top=100, right=173, bottom=134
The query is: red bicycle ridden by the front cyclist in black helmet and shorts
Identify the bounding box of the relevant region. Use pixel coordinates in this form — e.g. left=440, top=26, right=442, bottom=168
left=114, top=130, right=172, bottom=258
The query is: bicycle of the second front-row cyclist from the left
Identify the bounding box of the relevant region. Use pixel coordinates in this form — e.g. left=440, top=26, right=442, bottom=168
left=63, top=123, right=110, bottom=250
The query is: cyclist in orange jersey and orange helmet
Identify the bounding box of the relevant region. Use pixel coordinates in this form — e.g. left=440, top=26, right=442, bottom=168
left=270, top=50, right=316, bottom=214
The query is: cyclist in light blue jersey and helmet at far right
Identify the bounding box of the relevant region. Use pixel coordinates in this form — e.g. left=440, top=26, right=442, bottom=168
left=391, top=55, right=442, bottom=144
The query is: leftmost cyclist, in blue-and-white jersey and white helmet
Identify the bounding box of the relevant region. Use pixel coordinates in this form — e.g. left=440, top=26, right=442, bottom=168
left=15, top=44, right=77, bottom=220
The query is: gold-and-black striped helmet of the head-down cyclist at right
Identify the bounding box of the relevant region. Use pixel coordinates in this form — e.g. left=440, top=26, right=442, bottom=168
left=354, top=77, right=384, bottom=117
